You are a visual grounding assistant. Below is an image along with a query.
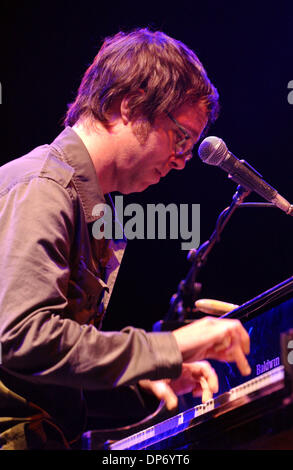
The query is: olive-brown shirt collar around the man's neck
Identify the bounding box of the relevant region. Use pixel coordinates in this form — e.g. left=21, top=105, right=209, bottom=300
left=51, top=127, right=105, bottom=223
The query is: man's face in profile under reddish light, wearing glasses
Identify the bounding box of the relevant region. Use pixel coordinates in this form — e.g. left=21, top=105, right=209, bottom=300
left=116, top=103, right=207, bottom=194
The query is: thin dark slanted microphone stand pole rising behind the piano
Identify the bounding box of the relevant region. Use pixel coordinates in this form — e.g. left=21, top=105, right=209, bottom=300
left=164, top=185, right=251, bottom=323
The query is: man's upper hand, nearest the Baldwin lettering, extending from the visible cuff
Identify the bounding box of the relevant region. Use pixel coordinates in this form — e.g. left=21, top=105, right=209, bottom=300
left=172, top=317, right=251, bottom=375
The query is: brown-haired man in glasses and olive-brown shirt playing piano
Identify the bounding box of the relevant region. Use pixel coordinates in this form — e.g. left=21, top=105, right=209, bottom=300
left=0, top=29, right=250, bottom=449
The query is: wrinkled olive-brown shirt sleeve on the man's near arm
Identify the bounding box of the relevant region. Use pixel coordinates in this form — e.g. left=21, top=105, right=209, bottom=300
left=0, top=177, right=182, bottom=390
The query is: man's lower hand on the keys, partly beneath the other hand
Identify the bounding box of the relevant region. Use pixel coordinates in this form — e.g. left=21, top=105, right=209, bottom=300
left=139, top=361, right=219, bottom=411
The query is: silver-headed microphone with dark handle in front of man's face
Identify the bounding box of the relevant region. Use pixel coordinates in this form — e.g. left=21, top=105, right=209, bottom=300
left=198, top=136, right=293, bottom=215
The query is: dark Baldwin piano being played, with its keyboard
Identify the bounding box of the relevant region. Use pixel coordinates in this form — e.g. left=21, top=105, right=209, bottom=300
left=83, top=277, right=293, bottom=451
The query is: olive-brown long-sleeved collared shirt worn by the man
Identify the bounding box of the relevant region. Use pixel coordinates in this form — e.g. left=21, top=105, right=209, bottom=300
left=0, top=127, right=182, bottom=445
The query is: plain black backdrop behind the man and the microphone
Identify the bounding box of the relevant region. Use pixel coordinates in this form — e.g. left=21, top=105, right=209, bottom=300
left=0, top=0, right=293, bottom=329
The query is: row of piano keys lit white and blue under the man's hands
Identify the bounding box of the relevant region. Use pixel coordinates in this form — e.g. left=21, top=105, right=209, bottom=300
left=108, top=366, right=285, bottom=450
